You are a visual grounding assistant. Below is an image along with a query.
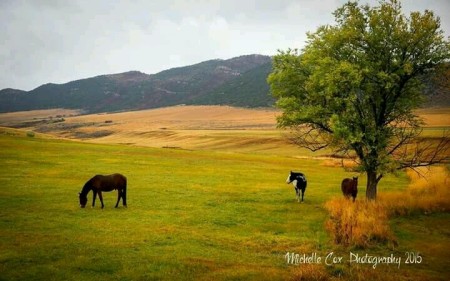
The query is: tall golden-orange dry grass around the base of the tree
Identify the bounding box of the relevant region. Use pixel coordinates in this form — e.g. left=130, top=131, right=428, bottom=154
left=325, top=167, right=450, bottom=248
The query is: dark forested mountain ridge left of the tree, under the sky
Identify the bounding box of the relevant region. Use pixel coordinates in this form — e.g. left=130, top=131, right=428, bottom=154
left=0, top=55, right=273, bottom=113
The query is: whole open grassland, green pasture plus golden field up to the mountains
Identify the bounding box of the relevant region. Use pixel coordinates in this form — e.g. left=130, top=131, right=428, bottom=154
left=0, top=106, right=450, bottom=281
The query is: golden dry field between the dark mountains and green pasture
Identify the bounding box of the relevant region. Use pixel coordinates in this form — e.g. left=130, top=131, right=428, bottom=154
left=0, top=106, right=450, bottom=157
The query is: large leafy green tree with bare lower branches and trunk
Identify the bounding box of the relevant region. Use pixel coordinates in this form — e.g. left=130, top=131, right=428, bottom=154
left=268, top=0, right=450, bottom=199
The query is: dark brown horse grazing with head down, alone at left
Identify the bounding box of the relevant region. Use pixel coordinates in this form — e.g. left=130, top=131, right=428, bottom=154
left=79, top=174, right=127, bottom=209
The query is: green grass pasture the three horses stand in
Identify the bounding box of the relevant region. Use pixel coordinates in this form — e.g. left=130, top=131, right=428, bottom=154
left=0, top=129, right=450, bottom=280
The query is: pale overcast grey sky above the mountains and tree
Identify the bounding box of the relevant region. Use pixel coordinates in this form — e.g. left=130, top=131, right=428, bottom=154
left=0, top=0, right=450, bottom=91
